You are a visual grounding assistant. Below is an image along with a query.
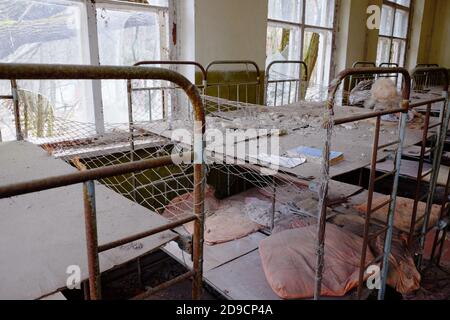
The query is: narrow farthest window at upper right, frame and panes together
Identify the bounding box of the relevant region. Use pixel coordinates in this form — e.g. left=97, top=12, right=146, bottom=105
left=377, top=0, right=411, bottom=66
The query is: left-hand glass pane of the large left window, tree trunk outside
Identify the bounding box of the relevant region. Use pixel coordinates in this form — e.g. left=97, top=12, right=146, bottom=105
left=0, top=0, right=93, bottom=140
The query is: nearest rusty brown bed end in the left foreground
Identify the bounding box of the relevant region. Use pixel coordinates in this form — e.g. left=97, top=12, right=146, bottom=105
left=0, top=64, right=205, bottom=300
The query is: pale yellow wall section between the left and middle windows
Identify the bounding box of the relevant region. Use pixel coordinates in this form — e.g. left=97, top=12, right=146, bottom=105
left=195, top=0, right=268, bottom=68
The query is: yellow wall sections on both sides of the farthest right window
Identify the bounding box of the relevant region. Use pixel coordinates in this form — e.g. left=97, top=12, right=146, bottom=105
left=335, top=0, right=450, bottom=72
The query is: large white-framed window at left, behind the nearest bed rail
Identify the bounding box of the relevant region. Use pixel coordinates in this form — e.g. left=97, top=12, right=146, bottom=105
left=0, top=0, right=169, bottom=140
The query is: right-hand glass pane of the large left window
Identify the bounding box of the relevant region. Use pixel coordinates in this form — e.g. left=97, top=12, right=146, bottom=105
left=97, top=8, right=168, bottom=123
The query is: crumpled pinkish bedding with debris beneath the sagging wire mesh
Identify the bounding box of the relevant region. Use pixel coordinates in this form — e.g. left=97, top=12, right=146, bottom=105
left=163, top=186, right=318, bottom=245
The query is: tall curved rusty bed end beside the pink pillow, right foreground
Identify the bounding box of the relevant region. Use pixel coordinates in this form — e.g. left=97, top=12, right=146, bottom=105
left=314, top=68, right=411, bottom=299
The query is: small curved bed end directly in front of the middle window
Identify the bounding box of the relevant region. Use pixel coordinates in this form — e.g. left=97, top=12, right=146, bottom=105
left=264, top=60, right=308, bottom=107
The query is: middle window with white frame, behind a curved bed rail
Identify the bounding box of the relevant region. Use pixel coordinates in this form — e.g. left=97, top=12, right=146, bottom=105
left=266, top=0, right=335, bottom=92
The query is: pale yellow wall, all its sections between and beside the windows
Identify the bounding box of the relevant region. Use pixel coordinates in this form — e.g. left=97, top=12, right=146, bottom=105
left=184, top=0, right=450, bottom=80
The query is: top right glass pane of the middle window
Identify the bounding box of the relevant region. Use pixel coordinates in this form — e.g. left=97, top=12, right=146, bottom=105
left=305, top=0, right=334, bottom=28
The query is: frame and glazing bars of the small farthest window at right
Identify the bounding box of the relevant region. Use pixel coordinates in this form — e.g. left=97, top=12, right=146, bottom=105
left=377, top=0, right=414, bottom=67
